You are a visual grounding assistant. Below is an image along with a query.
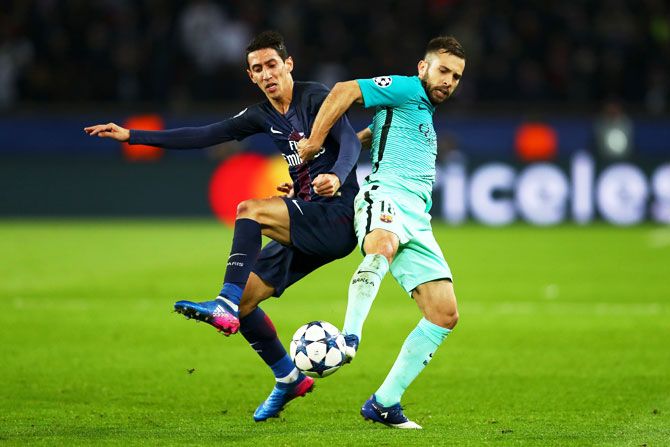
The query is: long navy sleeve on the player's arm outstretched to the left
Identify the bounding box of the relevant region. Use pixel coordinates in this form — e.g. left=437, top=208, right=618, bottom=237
left=129, top=109, right=264, bottom=149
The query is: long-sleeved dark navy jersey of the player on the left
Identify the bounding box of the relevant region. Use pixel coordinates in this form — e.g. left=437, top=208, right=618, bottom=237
left=130, top=82, right=361, bottom=202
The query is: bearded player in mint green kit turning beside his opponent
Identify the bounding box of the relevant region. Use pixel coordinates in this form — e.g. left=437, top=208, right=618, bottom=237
left=298, top=37, right=465, bottom=428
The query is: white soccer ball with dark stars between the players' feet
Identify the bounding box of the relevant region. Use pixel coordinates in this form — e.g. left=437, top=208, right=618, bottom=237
left=289, top=321, right=346, bottom=377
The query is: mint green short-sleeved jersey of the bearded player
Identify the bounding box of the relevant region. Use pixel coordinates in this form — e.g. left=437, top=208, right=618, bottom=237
left=356, top=76, right=437, bottom=204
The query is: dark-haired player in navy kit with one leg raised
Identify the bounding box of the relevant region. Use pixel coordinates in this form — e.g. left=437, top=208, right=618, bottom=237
left=84, top=31, right=360, bottom=421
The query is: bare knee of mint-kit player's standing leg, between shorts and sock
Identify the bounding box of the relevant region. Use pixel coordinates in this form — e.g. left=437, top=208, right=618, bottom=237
left=412, top=279, right=458, bottom=329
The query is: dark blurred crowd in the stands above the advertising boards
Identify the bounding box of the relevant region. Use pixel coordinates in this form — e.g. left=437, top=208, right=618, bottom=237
left=0, top=0, right=670, bottom=114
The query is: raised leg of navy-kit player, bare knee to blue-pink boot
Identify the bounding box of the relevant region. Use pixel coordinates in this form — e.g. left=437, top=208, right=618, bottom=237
left=175, top=197, right=291, bottom=335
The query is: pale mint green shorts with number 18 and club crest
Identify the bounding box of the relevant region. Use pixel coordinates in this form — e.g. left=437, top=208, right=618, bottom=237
left=354, top=183, right=452, bottom=294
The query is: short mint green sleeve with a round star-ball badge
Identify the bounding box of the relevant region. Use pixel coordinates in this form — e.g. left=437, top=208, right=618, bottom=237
left=356, top=75, right=417, bottom=108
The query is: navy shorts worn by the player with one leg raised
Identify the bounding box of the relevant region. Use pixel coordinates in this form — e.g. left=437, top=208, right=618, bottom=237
left=253, top=197, right=357, bottom=297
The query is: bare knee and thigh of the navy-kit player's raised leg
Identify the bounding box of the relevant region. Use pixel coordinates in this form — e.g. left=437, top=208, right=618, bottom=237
left=237, top=197, right=291, bottom=244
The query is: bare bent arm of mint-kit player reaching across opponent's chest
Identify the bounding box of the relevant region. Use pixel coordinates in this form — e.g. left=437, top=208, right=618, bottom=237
left=298, top=81, right=363, bottom=161
